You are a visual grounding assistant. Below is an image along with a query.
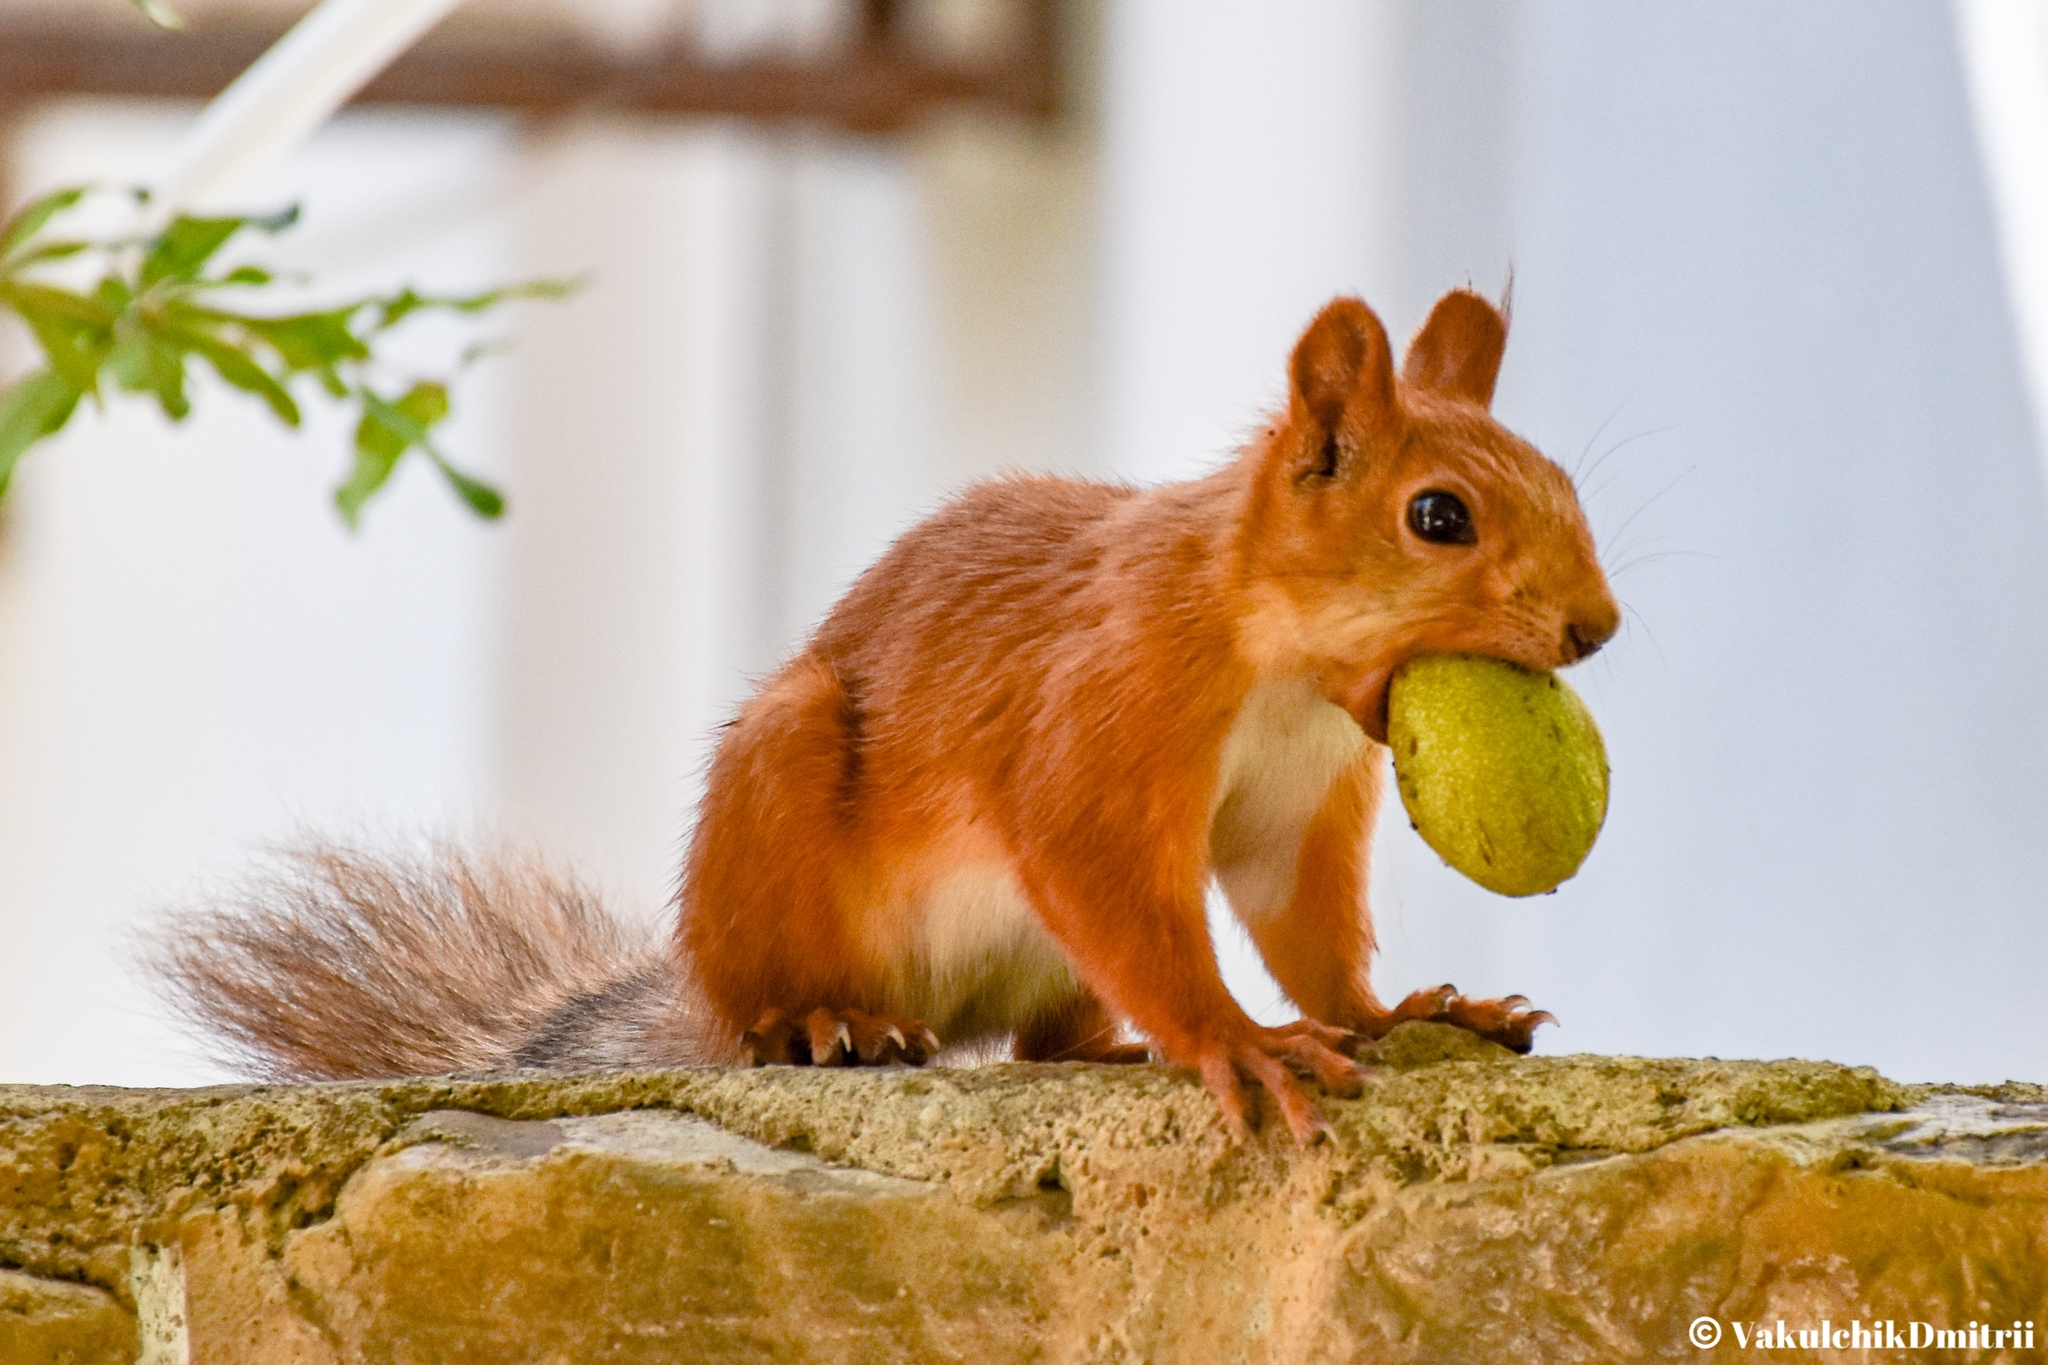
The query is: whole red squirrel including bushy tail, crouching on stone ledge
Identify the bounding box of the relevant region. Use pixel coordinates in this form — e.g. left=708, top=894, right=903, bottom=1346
left=156, top=291, right=1620, bottom=1142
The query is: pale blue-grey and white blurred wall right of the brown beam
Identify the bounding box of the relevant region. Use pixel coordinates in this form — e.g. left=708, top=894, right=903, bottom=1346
left=1104, top=0, right=2048, bottom=1081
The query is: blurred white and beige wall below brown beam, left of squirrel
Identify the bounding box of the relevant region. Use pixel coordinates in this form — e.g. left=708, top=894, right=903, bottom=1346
left=0, top=6, right=1094, bottom=1083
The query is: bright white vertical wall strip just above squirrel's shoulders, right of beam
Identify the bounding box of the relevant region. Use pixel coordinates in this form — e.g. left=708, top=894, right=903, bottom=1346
left=1100, top=0, right=1401, bottom=481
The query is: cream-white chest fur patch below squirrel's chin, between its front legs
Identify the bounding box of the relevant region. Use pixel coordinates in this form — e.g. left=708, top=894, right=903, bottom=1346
left=1208, top=677, right=1368, bottom=923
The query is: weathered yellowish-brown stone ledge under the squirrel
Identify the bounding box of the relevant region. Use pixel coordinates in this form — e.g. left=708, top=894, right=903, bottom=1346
left=0, top=1025, right=2048, bottom=1365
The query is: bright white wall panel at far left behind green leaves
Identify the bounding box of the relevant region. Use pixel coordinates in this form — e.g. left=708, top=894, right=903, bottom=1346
left=0, top=104, right=512, bottom=1083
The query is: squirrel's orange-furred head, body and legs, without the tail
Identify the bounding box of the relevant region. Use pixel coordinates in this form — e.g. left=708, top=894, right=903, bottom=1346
left=678, top=291, right=1618, bottom=1136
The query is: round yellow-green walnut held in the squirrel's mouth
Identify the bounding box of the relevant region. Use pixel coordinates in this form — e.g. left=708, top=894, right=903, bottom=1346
left=1386, top=655, right=1608, bottom=896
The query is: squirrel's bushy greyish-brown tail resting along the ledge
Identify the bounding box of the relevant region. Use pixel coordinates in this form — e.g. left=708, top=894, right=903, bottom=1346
left=141, top=841, right=723, bottom=1081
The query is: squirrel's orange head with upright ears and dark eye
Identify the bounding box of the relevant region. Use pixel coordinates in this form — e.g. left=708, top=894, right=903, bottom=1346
left=1239, top=289, right=1620, bottom=739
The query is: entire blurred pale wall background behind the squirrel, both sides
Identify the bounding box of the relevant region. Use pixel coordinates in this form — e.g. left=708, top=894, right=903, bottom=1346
left=0, top=0, right=2048, bottom=1085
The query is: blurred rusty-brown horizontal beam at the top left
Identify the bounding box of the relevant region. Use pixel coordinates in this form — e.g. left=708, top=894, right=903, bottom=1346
left=0, top=0, right=1059, bottom=133
